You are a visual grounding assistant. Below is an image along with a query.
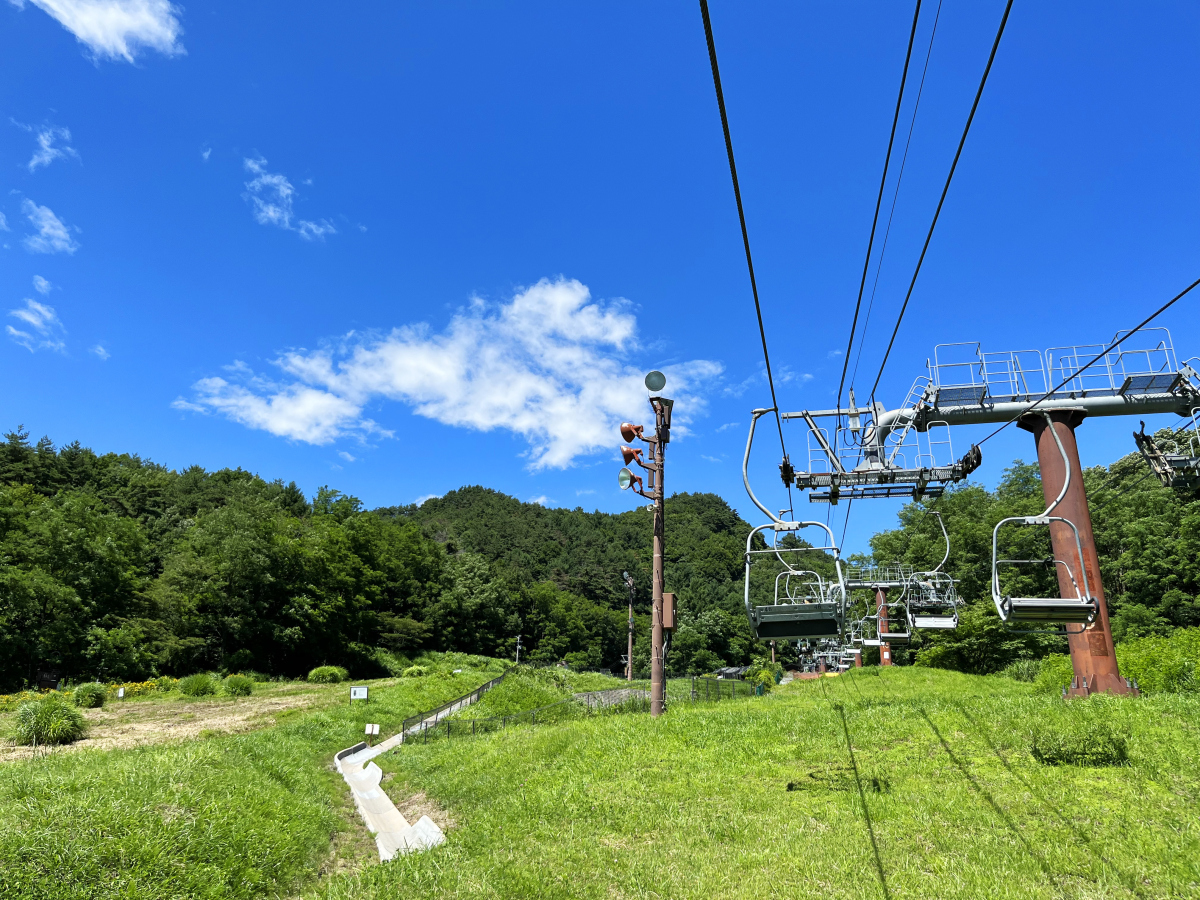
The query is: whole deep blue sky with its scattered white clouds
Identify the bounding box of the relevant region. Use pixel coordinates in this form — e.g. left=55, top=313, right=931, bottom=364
left=0, top=0, right=1200, bottom=550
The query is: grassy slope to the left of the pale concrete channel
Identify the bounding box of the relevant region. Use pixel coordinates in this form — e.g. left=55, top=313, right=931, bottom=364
left=0, top=662, right=497, bottom=900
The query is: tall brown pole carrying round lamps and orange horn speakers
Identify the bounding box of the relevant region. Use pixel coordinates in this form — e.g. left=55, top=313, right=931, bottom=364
left=618, top=372, right=674, bottom=718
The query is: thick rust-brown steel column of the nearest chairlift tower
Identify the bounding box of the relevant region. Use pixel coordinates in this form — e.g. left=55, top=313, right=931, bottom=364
left=1018, top=409, right=1132, bottom=697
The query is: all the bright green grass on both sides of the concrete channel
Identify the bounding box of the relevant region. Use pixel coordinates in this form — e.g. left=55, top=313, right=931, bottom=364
left=0, top=661, right=1200, bottom=900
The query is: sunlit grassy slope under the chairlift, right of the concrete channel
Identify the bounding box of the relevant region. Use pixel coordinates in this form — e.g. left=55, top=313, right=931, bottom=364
left=314, top=668, right=1200, bottom=900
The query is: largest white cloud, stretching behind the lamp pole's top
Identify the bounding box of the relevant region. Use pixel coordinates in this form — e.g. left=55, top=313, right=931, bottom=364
left=176, top=278, right=722, bottom=470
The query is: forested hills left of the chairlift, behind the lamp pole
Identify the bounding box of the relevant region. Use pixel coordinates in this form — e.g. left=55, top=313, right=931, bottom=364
left=0, top=430, right=751, bottom=691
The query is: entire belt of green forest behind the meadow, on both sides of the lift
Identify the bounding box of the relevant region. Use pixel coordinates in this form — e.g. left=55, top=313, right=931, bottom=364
left=0, top=430, right=1200, bottom=691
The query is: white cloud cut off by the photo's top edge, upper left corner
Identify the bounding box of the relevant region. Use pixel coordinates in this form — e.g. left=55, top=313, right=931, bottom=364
left=10, top=0, right=186, bottom=62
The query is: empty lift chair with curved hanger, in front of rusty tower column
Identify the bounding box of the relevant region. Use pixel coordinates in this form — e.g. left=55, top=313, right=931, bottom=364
left=991, top=413, right=1099, bottom=634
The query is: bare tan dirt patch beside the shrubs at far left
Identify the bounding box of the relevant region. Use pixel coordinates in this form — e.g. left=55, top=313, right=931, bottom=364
left=0, top=685, right=334, bottom=762
